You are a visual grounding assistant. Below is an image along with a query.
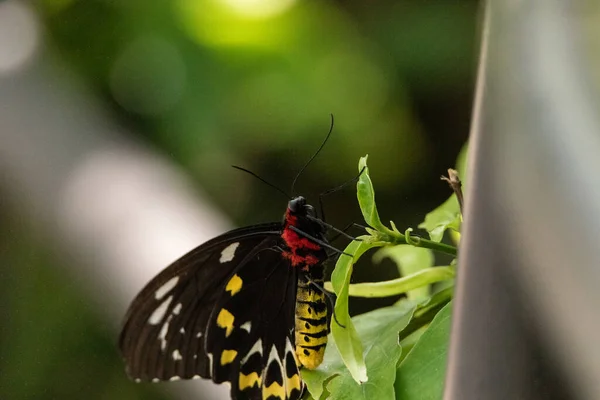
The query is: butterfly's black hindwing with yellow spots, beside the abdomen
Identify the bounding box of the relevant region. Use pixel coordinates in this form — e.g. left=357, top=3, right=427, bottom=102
left=206, top=247, right=304, bottom=400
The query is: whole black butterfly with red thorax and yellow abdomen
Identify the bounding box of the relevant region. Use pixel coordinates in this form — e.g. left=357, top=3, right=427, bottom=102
left=119, top=191, right=342, bottom=400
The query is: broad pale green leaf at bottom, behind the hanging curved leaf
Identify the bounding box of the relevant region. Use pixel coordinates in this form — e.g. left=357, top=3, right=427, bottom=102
left=302, top=302, right=415, bottom=400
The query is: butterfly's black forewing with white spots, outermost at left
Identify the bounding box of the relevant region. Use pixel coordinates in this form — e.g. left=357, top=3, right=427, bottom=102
left=119, top=223, right=282, bottom=381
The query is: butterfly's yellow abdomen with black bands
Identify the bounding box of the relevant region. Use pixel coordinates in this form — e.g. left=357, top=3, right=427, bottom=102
left=295, top=274, right=329, bottom=369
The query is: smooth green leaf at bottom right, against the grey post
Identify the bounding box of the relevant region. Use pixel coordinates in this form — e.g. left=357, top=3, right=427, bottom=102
left=394, top=302, right=452, bottom=400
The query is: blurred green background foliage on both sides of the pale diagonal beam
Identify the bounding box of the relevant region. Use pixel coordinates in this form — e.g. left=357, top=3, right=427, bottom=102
left=0, top=0, right=478, bottom=400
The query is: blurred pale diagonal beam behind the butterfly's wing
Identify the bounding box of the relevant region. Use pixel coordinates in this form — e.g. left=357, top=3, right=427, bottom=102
left=0, top=5, right=228, bottom=399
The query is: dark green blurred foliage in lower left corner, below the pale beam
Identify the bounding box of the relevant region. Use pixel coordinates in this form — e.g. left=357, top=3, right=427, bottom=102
left=0, top=198, right=165, bottom=400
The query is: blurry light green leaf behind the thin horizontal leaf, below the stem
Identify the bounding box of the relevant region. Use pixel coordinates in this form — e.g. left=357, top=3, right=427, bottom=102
left=373, top=244, right=435, bottom=301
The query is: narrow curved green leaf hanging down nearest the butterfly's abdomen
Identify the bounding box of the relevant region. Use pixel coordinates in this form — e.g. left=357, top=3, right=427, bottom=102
left=331, top=236, right=383, bottom=383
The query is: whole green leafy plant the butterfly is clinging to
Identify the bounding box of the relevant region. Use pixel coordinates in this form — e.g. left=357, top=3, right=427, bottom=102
left=302, top=151, right=465, bottom=400
